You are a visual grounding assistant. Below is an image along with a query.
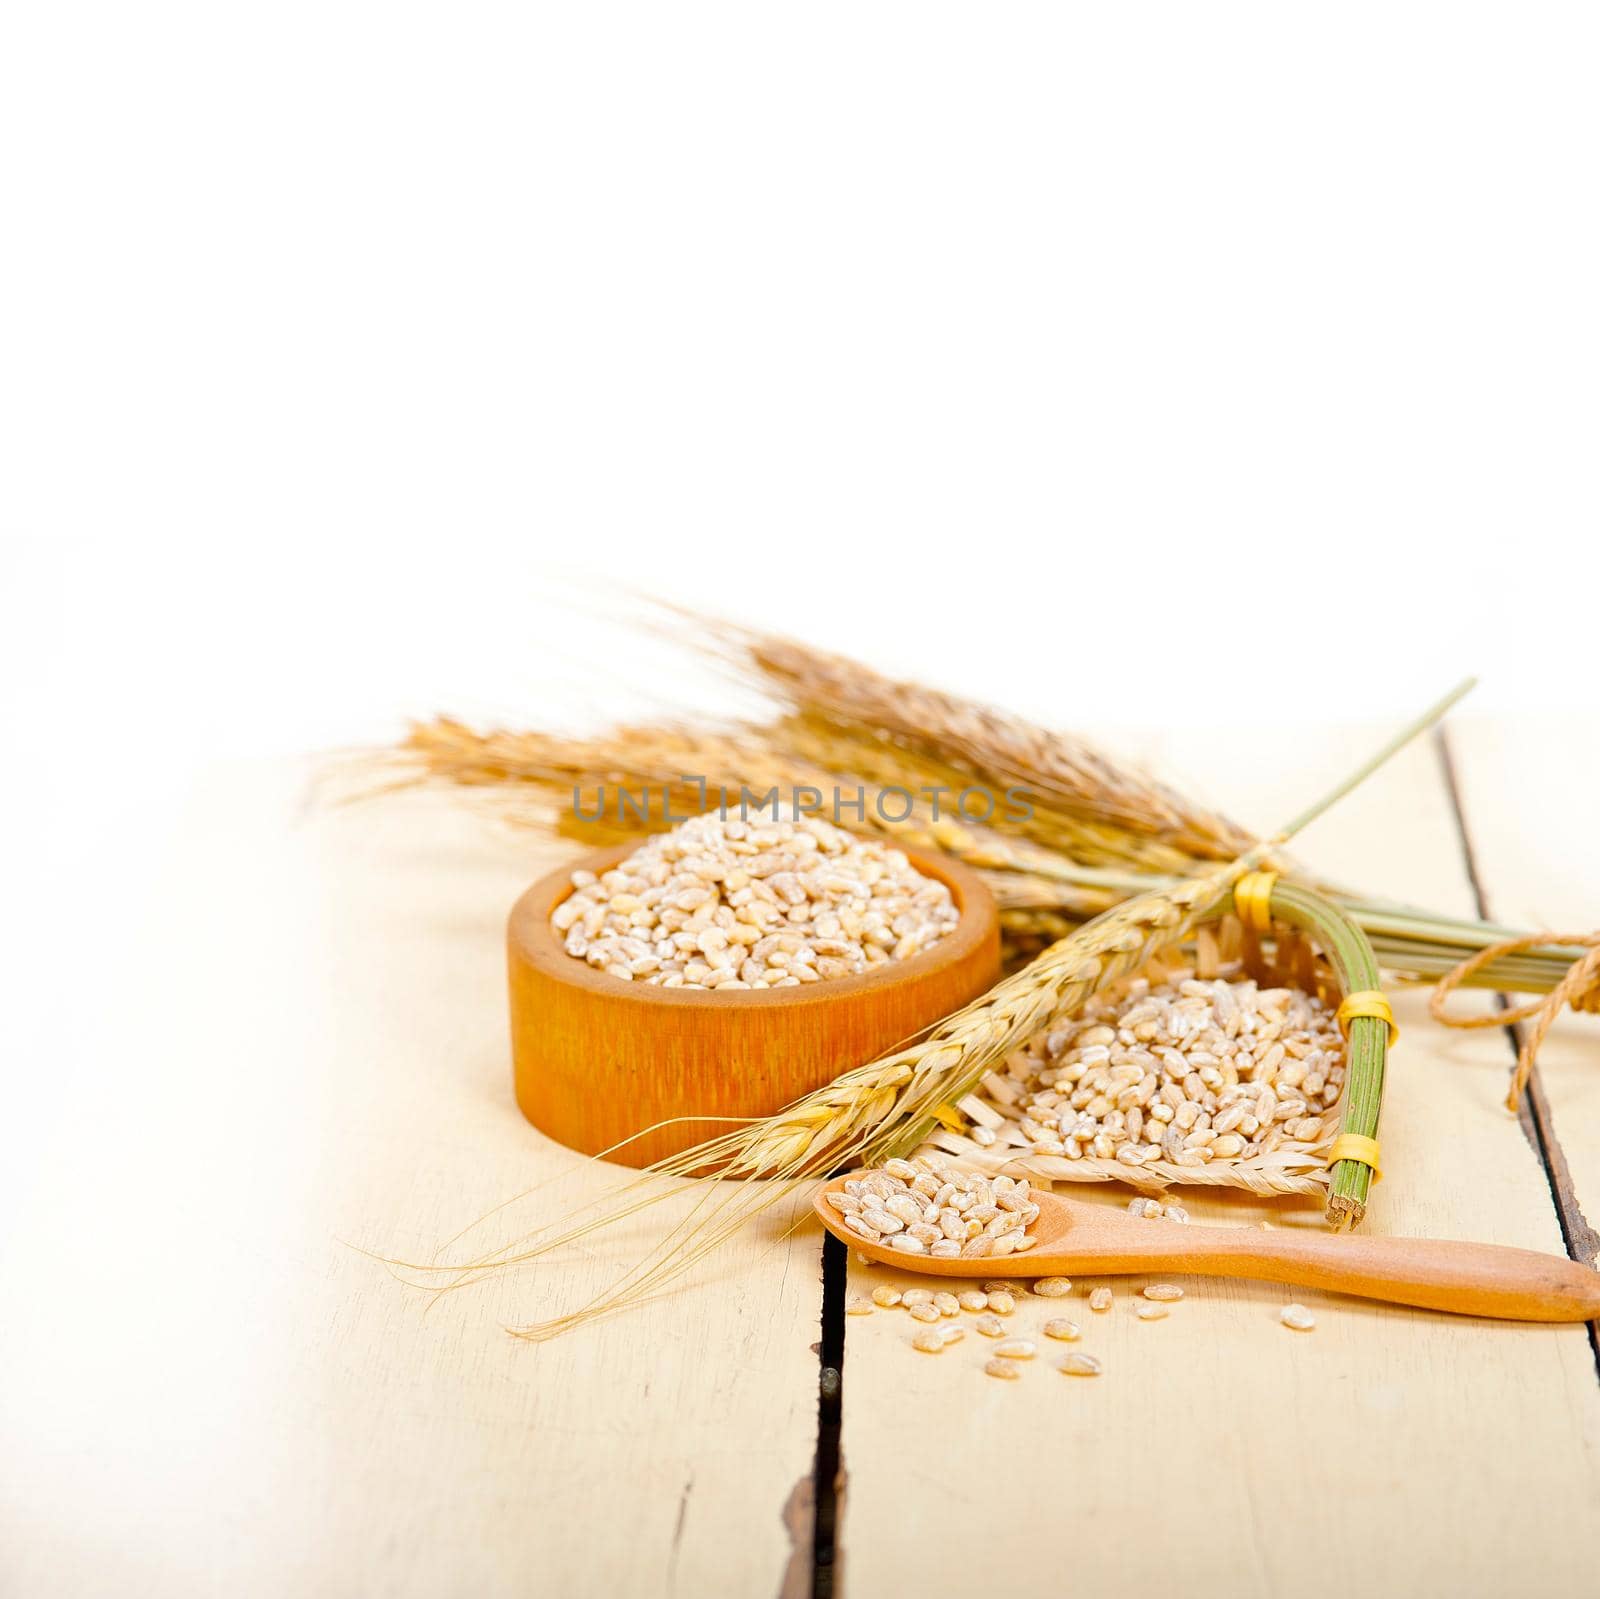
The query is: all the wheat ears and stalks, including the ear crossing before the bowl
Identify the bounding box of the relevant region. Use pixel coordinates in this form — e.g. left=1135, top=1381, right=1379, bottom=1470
left=356, top=621, right=1590, bottom=1338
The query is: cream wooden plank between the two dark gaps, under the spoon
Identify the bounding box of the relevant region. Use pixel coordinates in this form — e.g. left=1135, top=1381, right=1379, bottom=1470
left=842, top=725, right=1600, bottom=1599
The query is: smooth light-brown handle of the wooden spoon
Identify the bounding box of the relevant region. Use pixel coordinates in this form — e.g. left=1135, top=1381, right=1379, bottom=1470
left=1049, top=1228, right=1600, bottom=1322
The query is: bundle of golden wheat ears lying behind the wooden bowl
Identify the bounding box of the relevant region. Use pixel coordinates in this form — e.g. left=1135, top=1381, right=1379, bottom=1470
left=371, top=619, right=1589, bottom=994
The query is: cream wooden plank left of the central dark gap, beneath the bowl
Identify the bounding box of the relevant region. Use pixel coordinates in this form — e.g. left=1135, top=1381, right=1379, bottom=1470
left=0, top=770, right=821, bottom=1596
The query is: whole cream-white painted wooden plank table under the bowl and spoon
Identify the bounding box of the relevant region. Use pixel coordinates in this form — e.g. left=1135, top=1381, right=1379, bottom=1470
left=0, top=719, right=1600, bottom=1599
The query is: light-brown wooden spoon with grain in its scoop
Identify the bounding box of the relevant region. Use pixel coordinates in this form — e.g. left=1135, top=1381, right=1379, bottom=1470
left=814, top=1172, right=1600, bottom=1322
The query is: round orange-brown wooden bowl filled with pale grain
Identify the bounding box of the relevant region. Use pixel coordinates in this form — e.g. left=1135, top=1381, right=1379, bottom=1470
left=506, top=844, right=1000, bottom=1165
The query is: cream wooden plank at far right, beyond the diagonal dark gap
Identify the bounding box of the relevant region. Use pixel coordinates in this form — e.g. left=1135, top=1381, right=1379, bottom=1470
left=1450, top=717, right=1600, bottom=1260
